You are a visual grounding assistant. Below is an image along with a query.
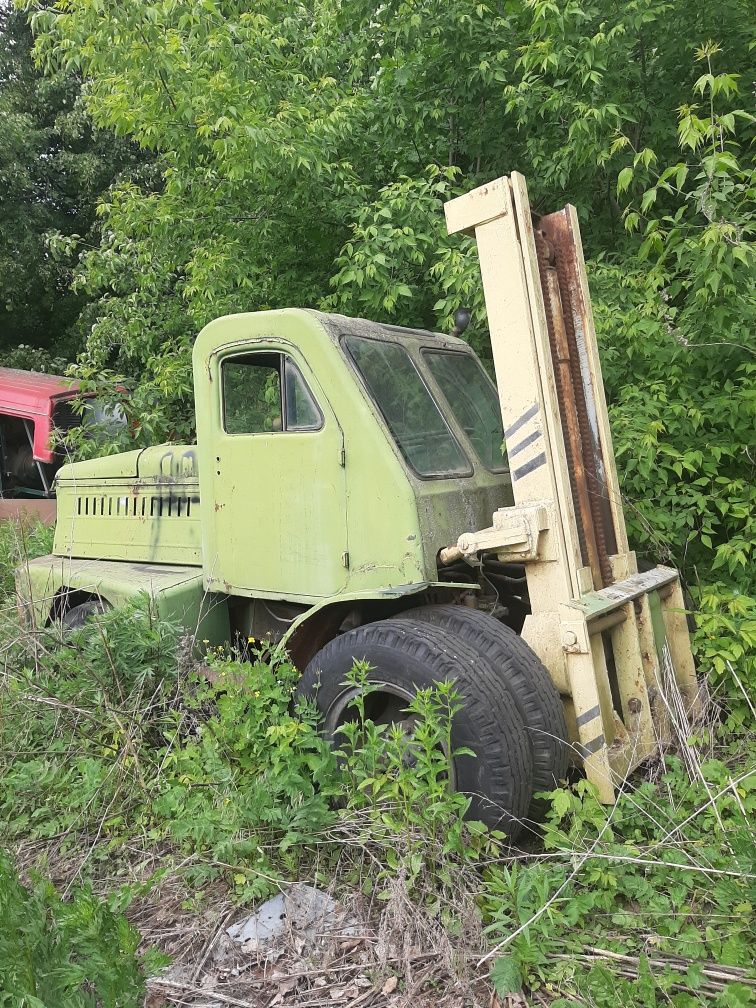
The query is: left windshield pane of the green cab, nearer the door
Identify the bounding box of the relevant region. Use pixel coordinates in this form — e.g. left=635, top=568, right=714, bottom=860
left=345, top=336, right=472, bottom=476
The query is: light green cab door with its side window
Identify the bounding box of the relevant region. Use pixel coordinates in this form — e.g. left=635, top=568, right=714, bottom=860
left=204, top=345, right=349, bottom=601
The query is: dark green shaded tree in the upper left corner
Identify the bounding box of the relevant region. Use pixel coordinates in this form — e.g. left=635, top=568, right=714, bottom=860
left=0, top=5, right=145, bottom=358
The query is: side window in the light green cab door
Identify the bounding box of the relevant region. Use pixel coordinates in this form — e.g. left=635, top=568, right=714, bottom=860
left=221, top=352, right=323, bottom=434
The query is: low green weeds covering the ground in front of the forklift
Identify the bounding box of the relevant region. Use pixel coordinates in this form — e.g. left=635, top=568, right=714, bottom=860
left=0, top=523, right=756, bottom=1008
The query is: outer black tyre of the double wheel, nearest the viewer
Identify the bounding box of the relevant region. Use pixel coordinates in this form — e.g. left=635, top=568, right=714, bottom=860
left=298, top=619, right=531, bottom=840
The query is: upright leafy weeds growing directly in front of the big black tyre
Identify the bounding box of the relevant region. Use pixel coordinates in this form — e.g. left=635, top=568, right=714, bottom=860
left=339, top=661, right=493, bottom=907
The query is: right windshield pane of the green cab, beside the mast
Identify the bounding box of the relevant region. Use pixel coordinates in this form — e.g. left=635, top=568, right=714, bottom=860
left=422, top=350, right=506, bottom=473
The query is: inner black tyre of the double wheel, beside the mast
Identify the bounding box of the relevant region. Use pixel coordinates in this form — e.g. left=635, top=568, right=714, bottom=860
left=398, top=605, right=569, bottom=818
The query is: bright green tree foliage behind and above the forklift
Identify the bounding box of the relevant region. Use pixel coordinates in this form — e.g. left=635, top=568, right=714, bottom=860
left=16, top=0, right=756, bottom=581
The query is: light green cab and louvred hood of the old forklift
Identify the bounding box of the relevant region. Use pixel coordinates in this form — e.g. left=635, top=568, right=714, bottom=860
left=18, top=309, right=511, bottom=662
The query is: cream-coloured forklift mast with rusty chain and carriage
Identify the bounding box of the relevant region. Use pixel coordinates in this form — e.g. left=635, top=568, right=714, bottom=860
left=442, top=172, right=700, bottom=802
